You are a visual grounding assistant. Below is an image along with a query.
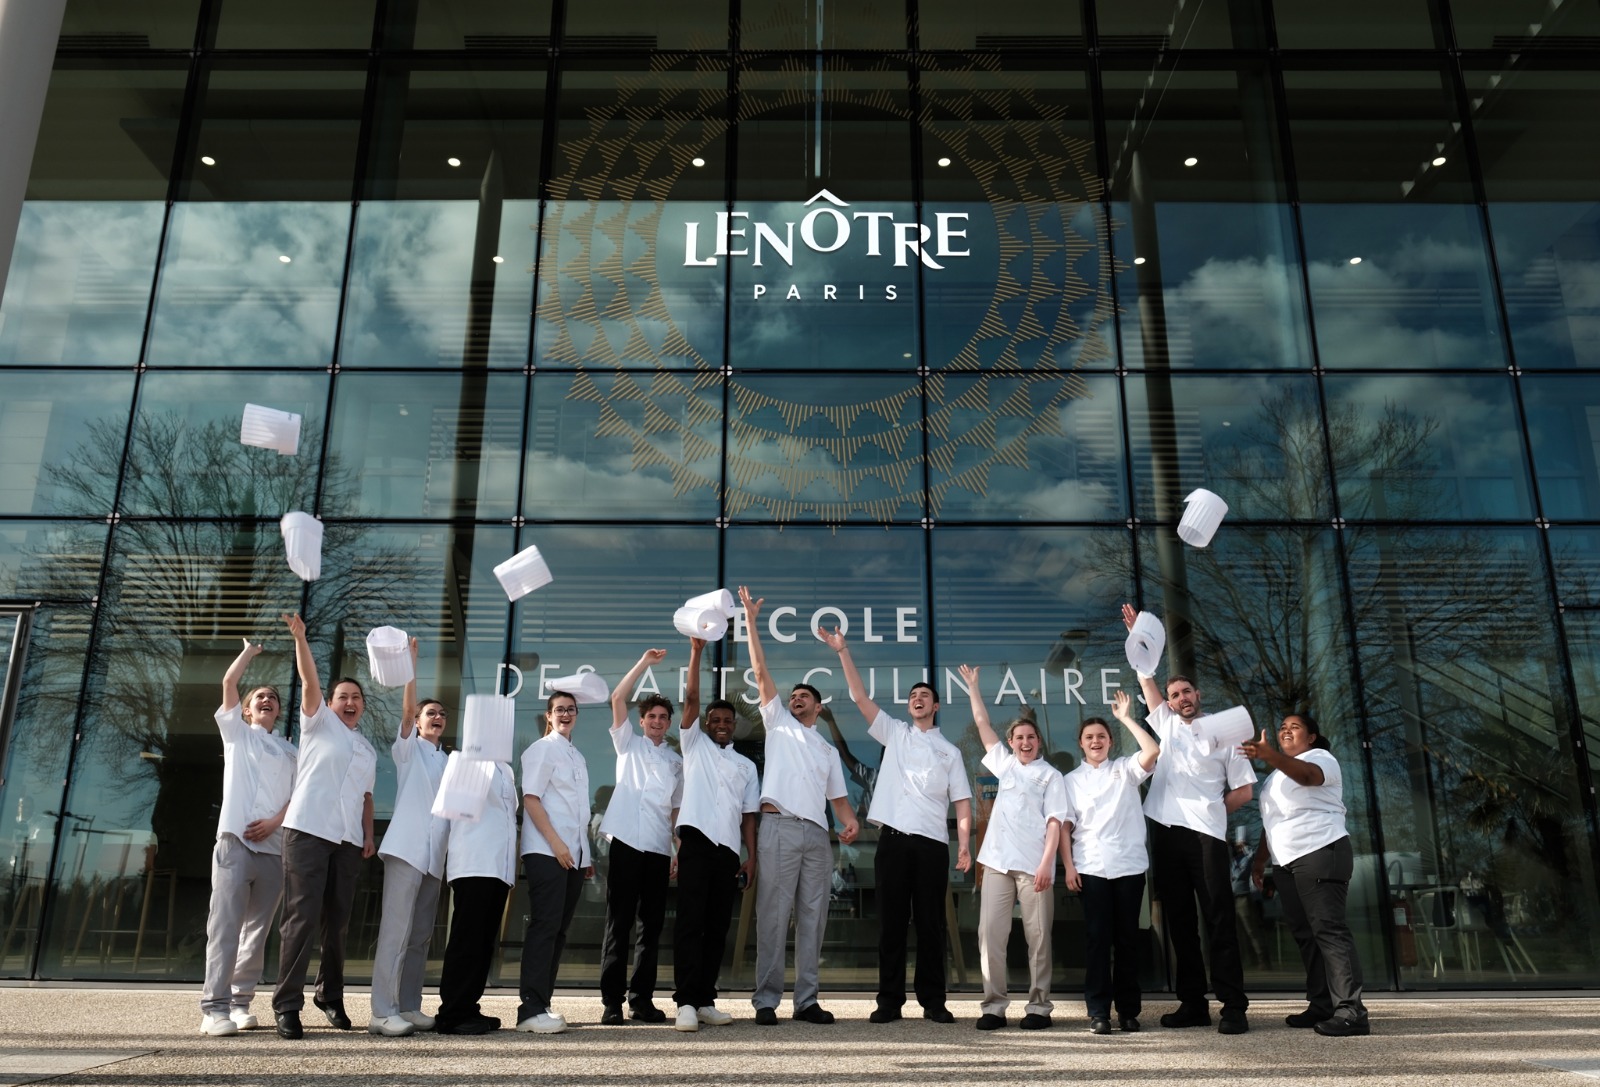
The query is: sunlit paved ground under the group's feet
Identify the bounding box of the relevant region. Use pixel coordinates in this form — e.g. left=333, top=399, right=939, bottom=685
left=0, top=988, right=1600, bottom=1087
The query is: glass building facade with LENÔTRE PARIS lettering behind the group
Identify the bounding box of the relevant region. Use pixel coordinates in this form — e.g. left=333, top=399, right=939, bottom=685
left=0, top=0, right=1600, bottom=993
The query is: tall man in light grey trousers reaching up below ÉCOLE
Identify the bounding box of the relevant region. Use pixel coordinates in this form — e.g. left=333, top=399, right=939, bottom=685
left=739, top=584, right=861, bottom=1026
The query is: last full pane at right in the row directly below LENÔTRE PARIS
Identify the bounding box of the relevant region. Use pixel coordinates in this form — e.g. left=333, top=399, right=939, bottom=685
left=1323, top=376, right=1533, bottom=520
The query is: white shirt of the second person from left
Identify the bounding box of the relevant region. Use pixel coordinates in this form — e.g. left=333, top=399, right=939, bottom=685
left=283, top=700, right=378, bottom=845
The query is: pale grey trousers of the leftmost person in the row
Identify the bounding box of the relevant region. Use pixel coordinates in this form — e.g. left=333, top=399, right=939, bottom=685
left=200, top=834, right=283, bottom=1015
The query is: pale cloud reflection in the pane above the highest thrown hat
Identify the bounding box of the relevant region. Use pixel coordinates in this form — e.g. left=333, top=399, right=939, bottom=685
left=149, top=202, right=350, bottom=365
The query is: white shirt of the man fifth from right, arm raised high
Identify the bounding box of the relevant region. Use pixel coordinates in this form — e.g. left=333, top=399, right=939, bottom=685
left=867, top=709, right=973, bottom=842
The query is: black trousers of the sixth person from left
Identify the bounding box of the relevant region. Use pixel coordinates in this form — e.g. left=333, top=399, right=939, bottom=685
left=600, top=837, right=672, bottom=1007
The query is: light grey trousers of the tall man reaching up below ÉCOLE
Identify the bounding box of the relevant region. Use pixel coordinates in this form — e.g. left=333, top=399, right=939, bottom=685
left=750, top=812, right=834, bottom=1012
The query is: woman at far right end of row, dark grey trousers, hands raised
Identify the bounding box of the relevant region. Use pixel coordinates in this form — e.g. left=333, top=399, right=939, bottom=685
left=1238, top=712, right=1371, bottom=1037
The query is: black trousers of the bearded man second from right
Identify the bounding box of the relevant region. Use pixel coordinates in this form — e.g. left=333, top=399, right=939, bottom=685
left=1147, top=820, right=1250, bottom=1012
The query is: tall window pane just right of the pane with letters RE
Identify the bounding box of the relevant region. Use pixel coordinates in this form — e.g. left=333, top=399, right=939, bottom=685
left=1104, top=64, right=1310, bottom=368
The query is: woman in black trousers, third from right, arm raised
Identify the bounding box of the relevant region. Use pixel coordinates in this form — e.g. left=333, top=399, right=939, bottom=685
left=1061, top=692, right=1162, bottom=1034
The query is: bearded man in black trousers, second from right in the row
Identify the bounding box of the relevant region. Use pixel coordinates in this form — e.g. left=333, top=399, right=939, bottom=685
left=1122, top=604, right=1256, bottom=1034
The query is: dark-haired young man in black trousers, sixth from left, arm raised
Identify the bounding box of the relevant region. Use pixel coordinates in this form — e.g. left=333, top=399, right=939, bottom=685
left=600, top=650, right=683, bottom=1026
